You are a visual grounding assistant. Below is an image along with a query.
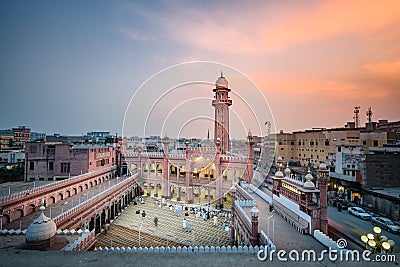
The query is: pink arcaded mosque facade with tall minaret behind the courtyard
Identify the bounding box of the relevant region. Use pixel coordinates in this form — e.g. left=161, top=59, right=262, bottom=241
left=121, top=72, right=254, bottom=209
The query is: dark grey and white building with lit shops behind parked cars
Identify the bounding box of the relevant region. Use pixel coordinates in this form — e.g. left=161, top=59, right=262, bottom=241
left=329, top=145, right=400, bottom=220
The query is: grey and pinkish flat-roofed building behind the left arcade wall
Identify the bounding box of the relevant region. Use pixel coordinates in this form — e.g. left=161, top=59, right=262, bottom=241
left=25, top=142, right=116, bottom=181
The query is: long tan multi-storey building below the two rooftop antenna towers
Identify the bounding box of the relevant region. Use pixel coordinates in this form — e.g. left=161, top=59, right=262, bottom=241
left=272, top=120, right=400, bottom=169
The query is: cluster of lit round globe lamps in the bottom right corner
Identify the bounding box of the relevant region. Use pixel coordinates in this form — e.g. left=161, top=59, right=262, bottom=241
left=361, top=226, right=395, bottom=253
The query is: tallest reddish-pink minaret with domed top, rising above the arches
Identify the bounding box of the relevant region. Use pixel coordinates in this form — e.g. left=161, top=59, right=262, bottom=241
left=212, top=71, right=232, bottom=154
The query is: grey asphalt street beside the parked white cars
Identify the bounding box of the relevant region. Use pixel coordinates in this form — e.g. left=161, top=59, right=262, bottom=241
left=328, top=206, right=400, bottom=253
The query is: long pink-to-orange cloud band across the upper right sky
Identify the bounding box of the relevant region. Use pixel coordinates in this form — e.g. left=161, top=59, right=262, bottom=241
left=165, top=0, right=400, bottom=54
